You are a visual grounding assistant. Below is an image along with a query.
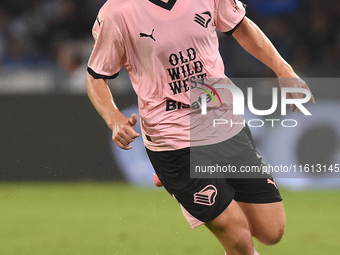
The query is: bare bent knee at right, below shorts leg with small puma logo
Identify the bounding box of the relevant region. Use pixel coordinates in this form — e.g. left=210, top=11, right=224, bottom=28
left=237, top=202, right=286, bottom=245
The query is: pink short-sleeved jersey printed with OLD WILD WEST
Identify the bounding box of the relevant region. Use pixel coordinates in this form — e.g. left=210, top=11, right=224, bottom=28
left=88, top=0, right=245, bottom=151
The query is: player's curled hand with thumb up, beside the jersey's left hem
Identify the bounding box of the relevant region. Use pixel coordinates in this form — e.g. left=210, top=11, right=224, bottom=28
left=112, top=113, right=140, bottom=150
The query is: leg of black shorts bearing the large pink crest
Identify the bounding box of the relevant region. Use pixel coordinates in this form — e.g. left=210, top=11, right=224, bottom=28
left=147, top=148, right=235, bottom=228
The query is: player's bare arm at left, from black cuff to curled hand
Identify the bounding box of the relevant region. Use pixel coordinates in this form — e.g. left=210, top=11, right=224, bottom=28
left=86, top=74, right=140, bottom=150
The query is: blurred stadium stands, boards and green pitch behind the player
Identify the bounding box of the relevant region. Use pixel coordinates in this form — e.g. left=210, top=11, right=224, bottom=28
left=0, top=0, right=340, bottom=254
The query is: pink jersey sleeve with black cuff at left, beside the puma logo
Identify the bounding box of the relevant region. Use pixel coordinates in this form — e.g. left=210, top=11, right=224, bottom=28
left=87, top=11, right=126, bottom=79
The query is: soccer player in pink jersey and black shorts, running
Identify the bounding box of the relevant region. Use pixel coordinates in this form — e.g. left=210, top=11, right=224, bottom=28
left=86, top=0, right=314, bottom=255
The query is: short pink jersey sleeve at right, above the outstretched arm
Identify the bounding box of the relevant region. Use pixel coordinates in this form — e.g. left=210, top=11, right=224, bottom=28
left=215, top=0, right=246, bottom=35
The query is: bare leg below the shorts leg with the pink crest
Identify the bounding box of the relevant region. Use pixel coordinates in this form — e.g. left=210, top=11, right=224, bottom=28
left=205, top=200, right=254, bottom=254
